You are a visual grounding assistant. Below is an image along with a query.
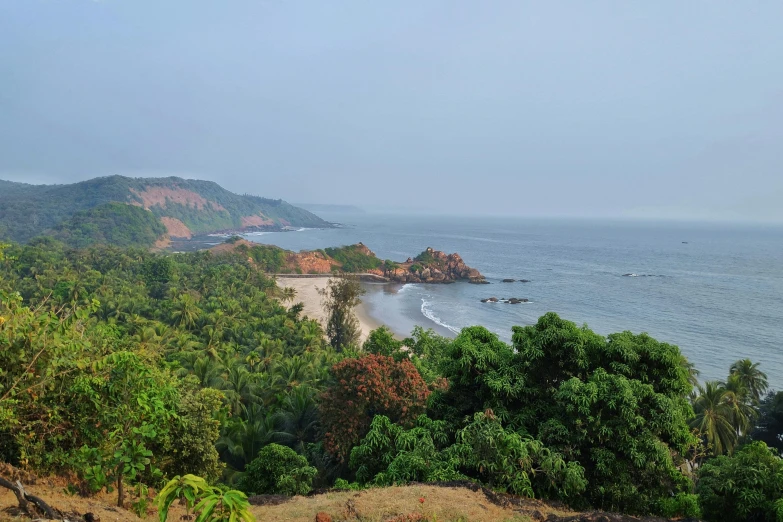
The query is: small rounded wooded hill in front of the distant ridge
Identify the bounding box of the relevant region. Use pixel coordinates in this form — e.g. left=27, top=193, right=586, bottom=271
left=50, top=203, right=166, bottom=248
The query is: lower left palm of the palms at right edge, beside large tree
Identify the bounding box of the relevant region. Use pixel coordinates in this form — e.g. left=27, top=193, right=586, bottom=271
left=690, top=381, right=737, bottom=455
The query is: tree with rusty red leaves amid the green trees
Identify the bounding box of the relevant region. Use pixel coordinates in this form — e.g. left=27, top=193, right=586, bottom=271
left=320, top=355, right=430, bottom=460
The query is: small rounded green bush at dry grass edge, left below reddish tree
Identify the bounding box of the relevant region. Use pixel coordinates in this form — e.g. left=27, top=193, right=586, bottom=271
left=239, top=444, right=318, bottom=496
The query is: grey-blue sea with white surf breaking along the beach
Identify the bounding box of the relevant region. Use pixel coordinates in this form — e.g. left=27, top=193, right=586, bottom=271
left=246, top=213, right=783, bottom=389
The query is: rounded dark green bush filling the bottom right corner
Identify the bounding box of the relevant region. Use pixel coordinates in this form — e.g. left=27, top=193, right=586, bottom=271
left=696, top=442, right=783, bottom=522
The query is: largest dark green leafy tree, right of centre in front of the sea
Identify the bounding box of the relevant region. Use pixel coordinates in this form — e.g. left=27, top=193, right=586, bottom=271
left=431, top=313, right=694, bottom=513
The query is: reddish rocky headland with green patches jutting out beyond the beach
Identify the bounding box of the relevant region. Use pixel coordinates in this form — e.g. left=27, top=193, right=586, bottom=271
left=211, top=238, right=486, bottom=284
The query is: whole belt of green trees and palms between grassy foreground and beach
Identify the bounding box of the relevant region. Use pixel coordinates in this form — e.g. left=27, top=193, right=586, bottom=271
left=0, top=239, right=783, bottom=521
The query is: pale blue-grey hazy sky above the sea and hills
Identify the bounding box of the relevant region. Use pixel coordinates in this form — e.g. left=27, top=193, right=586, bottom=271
left=0, top=0, right=783, bottom=221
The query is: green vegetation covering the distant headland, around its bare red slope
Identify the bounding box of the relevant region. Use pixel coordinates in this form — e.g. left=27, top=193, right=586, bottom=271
left=0, top=176, right=330, bottom=242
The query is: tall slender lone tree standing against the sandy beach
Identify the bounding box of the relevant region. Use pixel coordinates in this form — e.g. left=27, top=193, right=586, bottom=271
left=318, top=277, right=366, bottom=350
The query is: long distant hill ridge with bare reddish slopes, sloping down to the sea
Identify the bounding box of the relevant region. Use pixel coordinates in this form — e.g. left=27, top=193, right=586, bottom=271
left=0, top=176, right=332, bottom=243
